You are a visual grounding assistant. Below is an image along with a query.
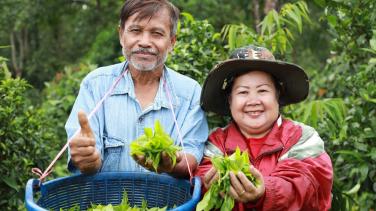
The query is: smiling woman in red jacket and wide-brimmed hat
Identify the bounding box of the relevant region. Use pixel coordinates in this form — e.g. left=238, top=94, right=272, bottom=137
left=196, top=46, right=333, bottom=210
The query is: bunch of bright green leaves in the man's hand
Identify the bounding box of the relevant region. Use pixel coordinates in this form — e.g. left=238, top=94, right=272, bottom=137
left=130, top=120, right=181, bottom=171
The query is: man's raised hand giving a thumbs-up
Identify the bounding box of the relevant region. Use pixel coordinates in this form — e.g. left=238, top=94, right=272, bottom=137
left=69, top=111, right=102, bottom=174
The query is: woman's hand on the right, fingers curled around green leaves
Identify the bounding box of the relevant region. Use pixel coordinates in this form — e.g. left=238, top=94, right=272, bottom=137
left=230, top=166, right=265, bottom=203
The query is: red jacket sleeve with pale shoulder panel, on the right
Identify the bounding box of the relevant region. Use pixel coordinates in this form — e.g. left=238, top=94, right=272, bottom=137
left=259, top=134, right=333, bottom=211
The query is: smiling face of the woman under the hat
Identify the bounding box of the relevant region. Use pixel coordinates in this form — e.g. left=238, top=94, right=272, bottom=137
left=229, top=71, right=279, bottom=138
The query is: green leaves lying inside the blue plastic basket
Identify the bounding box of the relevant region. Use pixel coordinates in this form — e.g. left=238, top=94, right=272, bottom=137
left=60, top=191, right=167, bottom=211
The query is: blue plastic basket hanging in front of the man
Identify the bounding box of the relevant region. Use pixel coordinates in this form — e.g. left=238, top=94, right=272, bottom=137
left=25, top=172, right=201, bottom=211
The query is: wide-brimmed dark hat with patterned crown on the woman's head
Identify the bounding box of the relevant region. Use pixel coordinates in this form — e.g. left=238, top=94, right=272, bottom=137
left=200, top=46, right=309, bottom=115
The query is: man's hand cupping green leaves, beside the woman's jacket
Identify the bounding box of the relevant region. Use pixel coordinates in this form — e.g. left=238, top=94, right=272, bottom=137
left=133, top=152, right=182, bottom=173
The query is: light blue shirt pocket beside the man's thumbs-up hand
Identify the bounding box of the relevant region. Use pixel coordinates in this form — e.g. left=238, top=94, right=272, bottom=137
left=101, top=136, right=125, bottom=171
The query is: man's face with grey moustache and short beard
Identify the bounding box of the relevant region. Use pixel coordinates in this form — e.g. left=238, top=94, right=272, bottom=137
left=119, top=9, right=176, bottom=71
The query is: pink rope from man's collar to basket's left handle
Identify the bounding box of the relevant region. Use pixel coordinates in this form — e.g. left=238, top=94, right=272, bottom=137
left=31, top=70, right=127, bottom=183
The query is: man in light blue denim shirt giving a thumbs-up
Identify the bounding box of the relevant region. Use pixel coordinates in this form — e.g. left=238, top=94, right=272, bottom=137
left=65, top=0, right=208, bottom=177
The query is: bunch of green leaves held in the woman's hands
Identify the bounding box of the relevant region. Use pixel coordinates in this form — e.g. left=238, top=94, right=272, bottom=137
left=196, top=148, right=259, bottom=211
